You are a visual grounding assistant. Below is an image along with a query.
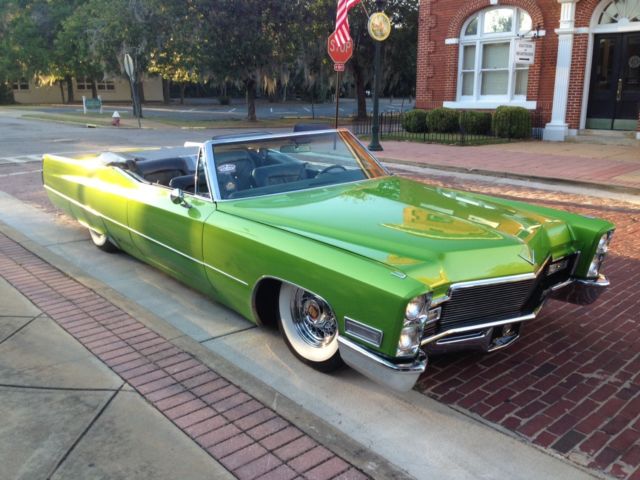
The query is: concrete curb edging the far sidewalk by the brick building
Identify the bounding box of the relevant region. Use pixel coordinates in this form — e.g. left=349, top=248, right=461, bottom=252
left=379, top=157, right=640, bottom=195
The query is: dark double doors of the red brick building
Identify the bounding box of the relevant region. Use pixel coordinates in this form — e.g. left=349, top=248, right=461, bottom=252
left=586, top=32, right=640, bottom=130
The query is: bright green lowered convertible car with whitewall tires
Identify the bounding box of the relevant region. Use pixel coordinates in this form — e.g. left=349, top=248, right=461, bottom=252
left=43, top=130, right=614, bottom=390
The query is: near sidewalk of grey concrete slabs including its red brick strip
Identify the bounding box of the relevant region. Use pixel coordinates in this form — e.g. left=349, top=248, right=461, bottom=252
left=0, top=233, right=372, bottom=480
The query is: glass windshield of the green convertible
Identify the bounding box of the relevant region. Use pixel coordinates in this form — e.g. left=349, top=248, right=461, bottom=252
left=213, top=130, right=388, bottom=199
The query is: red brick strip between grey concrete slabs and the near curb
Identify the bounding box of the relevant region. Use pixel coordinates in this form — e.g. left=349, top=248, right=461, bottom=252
left=0, top=233, right=368, bottom=480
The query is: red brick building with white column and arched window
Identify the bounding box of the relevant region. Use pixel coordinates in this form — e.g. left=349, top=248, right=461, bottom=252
left=416, top=0, right=640, bottom=141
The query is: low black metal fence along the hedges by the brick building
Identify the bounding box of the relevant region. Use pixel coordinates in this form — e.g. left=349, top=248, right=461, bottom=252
left=351, top=111, right=544, bottom=145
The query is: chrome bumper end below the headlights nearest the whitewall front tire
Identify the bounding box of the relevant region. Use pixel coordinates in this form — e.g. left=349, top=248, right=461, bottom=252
left=338, top=336, right=427, bottom=392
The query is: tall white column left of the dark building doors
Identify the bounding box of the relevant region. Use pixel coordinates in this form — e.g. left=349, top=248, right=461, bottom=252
left=543, top=0, right=580, bottom=142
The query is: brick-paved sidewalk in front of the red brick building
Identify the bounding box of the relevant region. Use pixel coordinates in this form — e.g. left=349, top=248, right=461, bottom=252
left=377, top=141, right=640, bottom=193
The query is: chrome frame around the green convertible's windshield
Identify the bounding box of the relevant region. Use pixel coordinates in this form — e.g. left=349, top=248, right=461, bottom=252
left=202, top=128, right=390, bottom=202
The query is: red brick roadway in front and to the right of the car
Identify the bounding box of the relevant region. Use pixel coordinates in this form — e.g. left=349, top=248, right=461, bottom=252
left=400, top=172, right=640, bottom=480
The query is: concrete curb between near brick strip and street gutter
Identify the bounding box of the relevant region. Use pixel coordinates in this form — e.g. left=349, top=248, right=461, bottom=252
left=0, top=221, right=413, bottom=480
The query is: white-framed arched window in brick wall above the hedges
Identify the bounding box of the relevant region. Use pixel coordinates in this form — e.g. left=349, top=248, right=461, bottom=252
left=457, top=6, right=533, bottom=104
